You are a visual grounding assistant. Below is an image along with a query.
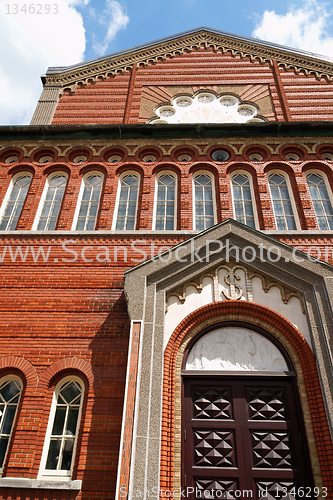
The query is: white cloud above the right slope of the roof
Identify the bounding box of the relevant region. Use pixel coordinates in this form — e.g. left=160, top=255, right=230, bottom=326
left=252, top=0, right=333, bottom=57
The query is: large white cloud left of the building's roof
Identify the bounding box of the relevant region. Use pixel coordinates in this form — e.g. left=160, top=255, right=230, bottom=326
left=0, top=0, right=89, bottom=125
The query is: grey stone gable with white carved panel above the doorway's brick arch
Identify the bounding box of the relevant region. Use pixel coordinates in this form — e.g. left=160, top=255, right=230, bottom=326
left=125, top=219, right=333, bottom=346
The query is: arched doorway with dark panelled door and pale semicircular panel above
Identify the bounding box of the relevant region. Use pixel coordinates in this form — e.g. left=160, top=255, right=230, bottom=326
left=182, top=323, right=313, bottom=500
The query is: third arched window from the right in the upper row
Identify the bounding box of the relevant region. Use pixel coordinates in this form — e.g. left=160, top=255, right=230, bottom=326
left=231, top=174, right=255, bottom=228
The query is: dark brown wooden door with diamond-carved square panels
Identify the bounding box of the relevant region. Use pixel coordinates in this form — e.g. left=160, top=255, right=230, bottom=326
left=182, top=376, right=312, bottom=500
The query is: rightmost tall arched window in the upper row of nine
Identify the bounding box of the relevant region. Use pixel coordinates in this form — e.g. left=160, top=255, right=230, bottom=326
left=306, top=173, right=333, bottom=230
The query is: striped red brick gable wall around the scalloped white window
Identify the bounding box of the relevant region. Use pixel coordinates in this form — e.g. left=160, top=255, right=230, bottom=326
left=52, top=47, right=333, bottom=125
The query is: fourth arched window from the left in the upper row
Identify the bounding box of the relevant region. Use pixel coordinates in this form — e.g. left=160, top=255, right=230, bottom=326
left=115, top=174, right=139, bottom=230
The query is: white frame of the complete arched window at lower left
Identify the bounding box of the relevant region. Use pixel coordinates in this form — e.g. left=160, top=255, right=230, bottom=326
left=38, top=375, right=85, bottom=481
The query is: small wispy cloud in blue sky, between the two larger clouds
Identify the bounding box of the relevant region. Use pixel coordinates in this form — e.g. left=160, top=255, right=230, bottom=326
left=92, top=0, right=129, bottom=55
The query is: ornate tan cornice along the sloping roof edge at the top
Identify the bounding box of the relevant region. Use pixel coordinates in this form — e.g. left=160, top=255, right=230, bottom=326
left=45, top=30, right=333, bottom=92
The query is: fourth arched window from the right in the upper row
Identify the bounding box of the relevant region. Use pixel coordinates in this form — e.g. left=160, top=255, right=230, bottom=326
left=194, top=174, right=215, bottom=231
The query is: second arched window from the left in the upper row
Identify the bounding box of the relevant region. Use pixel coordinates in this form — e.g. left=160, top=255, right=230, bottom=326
left=33, top=172, right=67, bottom=231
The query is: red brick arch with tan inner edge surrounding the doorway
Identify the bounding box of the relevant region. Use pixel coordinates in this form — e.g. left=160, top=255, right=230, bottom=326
left=160, top=301, right=333, bottom=497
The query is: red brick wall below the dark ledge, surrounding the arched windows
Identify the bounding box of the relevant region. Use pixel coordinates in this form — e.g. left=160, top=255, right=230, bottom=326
left=0, top=138, right=333, bottom=500
